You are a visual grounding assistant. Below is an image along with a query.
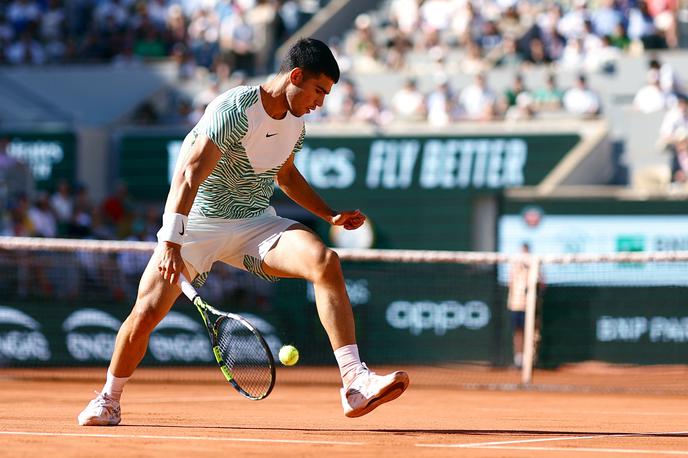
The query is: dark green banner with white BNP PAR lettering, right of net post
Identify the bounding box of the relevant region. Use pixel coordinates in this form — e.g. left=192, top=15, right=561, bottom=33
left=539, top=287, right=688, bottom=367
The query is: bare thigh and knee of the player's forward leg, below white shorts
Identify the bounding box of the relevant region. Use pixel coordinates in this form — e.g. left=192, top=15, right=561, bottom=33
left=262, top=224, right=333, bottom=279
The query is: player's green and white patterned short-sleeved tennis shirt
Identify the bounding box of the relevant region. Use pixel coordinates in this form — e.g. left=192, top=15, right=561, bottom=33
left=189, top=86, right=306, bottom=219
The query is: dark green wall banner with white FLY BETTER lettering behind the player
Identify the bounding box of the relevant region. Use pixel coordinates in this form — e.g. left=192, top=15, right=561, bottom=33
left=117, top=132, right=580, bottom=250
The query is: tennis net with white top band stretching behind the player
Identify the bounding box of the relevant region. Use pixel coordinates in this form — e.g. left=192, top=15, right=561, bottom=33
left=0, top=237, right=688, bottom=392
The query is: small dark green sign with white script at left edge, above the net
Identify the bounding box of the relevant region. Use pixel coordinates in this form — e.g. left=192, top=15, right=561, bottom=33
left=0, top=131, right=76, bottom=191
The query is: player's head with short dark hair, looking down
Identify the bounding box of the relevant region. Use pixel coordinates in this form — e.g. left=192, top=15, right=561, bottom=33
left=280, top=38, right=339, bottom=116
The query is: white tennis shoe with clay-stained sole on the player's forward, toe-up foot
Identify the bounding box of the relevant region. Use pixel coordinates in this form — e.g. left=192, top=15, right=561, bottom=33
left=341, top=364, right=409, bottom=418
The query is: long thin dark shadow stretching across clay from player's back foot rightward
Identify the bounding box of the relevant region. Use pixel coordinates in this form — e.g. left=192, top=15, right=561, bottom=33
left=119, top=424, right=688, bottom=437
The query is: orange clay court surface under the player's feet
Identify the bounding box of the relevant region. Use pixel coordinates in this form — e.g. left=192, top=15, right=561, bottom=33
left=0, top=367, right=688, bottom=458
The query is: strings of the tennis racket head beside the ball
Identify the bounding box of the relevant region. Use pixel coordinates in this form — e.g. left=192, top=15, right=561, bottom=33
left=217, top=317, right=273, bottom=399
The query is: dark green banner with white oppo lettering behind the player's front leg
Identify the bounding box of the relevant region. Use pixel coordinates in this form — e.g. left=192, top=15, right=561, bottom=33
left=274, top=263, right=511, bottom=365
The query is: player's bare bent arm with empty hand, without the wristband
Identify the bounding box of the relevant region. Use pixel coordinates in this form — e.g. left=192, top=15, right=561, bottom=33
left=275, top=154, right=365, bottom=230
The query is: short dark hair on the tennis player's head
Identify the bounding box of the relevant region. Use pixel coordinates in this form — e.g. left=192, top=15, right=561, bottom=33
left=280, top=38, right=339, bottom=83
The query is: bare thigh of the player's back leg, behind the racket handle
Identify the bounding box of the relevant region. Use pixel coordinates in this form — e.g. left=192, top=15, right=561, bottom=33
left=133, top=248, right=188, bottom=321
